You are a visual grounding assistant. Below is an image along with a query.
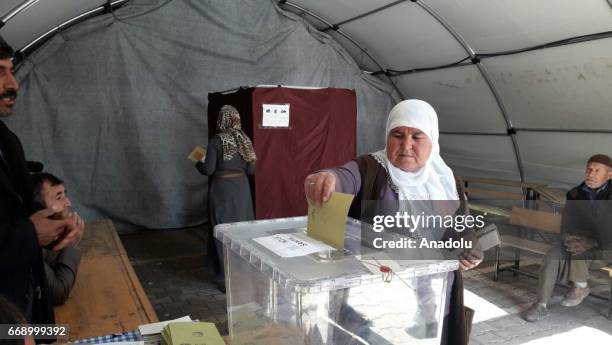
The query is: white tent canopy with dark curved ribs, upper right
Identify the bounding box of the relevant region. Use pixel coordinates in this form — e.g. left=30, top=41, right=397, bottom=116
left=284, top=0, right=612, bottom=184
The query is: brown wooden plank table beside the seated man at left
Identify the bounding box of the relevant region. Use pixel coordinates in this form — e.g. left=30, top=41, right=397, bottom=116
left=55, top=220, right=158, bottom=341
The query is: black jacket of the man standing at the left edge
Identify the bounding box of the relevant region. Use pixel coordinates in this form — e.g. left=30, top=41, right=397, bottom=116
left=0, top=121, right=54, bottom=324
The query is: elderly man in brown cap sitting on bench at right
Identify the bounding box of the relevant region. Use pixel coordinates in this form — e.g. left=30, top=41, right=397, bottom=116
left=525, top=154, right=612, bottom=322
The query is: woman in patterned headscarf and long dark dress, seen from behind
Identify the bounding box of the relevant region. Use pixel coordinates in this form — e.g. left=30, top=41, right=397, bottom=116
left=196, top=105, right=256, bottom=283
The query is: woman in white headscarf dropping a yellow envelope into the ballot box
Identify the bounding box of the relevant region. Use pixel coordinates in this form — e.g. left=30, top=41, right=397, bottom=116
left=304, top=99, right=482, bottom=344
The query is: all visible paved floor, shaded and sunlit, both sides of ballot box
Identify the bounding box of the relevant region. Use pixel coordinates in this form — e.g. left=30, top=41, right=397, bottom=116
left=120, top=226, right=612, bottom=345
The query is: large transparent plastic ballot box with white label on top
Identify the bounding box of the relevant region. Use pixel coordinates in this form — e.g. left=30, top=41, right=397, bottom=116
left=215, top=217, right=458, bottom=345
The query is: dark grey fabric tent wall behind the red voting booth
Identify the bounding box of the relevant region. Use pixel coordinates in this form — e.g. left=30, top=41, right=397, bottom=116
left=7, top=0, right=397, bottom=228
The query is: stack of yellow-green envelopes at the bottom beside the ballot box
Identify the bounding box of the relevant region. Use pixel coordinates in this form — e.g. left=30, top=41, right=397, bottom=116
left=161, top=322, right=225, bottom=345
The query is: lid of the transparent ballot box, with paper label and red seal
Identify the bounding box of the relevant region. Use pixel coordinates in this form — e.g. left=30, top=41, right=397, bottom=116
left=214, top=217, right=459, bottom=292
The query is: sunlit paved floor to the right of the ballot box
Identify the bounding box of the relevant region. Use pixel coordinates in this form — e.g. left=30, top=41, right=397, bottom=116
left=465, top=263, right=612, bottom=345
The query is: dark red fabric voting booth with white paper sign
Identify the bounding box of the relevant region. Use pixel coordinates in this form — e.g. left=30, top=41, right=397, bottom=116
left=208, top=87, right=357, bottom=219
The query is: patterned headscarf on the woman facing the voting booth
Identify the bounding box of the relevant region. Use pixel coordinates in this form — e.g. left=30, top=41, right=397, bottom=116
left=217, top=105, right=257, bottom=162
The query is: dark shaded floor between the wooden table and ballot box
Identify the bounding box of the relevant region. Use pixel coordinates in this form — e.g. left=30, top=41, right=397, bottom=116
left=120, top=226, right=228, bottom=334
